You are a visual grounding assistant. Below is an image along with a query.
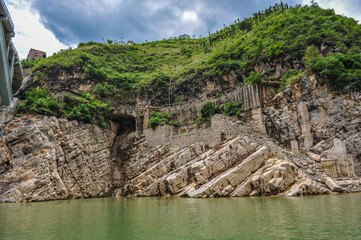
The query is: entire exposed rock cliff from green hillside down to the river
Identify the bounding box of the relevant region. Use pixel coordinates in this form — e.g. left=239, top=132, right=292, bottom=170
left=0, top=73, right=361, bottom=202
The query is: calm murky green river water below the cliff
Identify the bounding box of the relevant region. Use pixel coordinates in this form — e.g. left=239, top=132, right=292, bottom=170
left=0, top=194, right=361, bottom=240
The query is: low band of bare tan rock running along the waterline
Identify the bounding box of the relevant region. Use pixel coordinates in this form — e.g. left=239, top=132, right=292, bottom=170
left=0, top=108, right=360, bottom=202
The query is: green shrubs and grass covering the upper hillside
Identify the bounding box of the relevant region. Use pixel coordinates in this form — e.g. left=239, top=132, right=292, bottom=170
left=19, top=3, right=361, bottom=124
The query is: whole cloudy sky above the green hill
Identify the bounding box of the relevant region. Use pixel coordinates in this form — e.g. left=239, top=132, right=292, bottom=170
left=5, top=0, right=361, bottom=58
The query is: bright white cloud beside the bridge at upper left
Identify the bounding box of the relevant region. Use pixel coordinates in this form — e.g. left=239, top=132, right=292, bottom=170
left=6, top=0, right=69, bottom=58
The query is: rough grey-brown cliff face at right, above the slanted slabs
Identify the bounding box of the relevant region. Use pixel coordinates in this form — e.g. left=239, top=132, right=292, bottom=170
left=263, top=77, right=361, bottom=176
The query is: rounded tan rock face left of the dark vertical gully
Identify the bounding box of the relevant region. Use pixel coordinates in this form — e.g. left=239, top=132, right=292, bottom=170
left=0, top=116, right=114, bottom=202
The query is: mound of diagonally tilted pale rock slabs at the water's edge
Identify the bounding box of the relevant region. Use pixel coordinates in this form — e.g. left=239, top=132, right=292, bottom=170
left=122, top=119, right=348, bottom=198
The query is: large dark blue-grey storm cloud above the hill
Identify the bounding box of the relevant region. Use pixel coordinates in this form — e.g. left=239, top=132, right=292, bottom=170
left=31, top=0, right=296, bottom=45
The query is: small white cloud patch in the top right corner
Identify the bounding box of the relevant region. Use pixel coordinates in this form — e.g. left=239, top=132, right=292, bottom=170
left=303, top=0, right=361, bottom=22
